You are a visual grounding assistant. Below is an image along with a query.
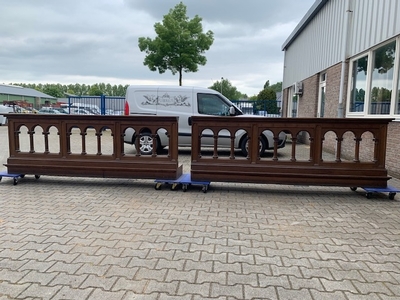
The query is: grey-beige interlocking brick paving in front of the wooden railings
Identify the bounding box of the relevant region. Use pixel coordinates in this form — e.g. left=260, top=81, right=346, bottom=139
left=0, top=126, right=400, bottom=300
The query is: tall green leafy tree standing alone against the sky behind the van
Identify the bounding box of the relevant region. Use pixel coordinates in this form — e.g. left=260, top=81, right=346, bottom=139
left=139, top=2, right=214, bottom=85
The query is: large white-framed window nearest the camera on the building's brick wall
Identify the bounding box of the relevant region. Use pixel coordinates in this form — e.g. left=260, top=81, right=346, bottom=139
left=347, top=39, right=400, bottom=117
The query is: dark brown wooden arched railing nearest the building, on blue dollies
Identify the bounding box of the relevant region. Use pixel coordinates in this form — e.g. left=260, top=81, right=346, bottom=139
left=191, top=116, right=392, bottom=187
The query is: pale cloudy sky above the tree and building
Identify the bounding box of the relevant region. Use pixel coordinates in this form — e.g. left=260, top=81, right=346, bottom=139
left=0, top=0, right=315, bottom=96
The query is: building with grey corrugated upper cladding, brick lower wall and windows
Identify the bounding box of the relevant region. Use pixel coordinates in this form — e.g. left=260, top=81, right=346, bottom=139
left=282, top=0, right=400, bottom=176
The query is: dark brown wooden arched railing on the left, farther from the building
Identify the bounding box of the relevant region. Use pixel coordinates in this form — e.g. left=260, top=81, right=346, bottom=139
left=6, top=114, right=182, bottom=179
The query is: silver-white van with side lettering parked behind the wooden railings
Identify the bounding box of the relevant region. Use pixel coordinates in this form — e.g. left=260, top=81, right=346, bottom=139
left=124, top=85, right=286, bottom=156
